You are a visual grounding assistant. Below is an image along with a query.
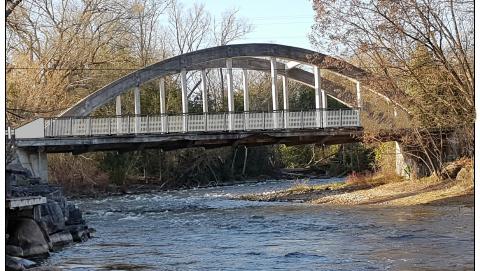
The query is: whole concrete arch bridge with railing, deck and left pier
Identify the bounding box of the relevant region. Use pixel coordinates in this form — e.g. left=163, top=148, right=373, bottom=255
left=14, top=44, right=390, bottom=180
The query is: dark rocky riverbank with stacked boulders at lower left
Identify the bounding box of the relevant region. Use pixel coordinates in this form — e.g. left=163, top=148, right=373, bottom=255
left=5, top=166, right=95, bottom=270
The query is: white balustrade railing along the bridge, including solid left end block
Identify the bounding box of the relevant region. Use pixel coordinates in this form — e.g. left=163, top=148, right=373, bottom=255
left=15, top=109, right=360, bottom=138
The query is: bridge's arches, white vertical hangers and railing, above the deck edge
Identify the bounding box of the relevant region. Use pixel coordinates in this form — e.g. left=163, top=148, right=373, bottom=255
left=16, top=43, right=366, bottom=138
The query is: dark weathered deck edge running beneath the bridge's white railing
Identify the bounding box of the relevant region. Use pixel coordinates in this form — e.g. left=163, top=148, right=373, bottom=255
left=15, top=127, right=363, bottom=153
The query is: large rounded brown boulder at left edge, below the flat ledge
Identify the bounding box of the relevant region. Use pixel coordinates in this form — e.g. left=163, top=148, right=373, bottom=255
left=7, top=218, right=49, bottom=257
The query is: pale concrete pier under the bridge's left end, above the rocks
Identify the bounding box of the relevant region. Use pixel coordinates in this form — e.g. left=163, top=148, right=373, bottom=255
left=17, top=149, right=48, bottom=183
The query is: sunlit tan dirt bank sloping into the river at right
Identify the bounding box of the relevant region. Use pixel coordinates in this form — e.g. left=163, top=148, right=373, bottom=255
left=240, top=160, right=474, bottom=206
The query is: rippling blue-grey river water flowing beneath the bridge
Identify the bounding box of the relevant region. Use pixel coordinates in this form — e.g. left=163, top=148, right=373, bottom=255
left=44, top=179, right=474, bottom=270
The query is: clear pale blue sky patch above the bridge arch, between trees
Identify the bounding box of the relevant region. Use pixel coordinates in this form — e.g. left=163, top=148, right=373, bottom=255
left=182, top=0, right=314, bottom=49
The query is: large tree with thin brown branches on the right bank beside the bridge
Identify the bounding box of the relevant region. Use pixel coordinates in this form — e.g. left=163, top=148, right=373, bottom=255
left=311, top=0, right=475, bottom=176
